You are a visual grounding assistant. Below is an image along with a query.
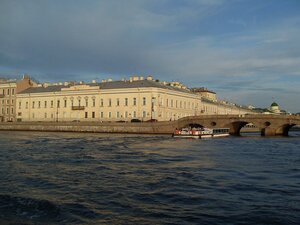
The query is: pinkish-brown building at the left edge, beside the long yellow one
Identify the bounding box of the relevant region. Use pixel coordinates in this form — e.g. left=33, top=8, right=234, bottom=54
left=0, top=75, right=36, bottom=122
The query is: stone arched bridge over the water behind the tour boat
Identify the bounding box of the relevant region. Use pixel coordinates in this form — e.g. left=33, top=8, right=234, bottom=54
left=173, top=114, right=300, bottom=136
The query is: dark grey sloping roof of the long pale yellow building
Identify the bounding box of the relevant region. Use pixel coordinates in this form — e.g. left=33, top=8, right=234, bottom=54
left=19, top=80, right=192, bottom=94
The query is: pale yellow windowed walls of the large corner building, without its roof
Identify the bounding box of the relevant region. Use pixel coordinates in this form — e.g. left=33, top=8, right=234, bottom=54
left=17, top=85, right=201, bottom=121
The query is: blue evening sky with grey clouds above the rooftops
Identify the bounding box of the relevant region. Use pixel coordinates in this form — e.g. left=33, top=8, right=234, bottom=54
left=0, top=0, right=300, bottom=113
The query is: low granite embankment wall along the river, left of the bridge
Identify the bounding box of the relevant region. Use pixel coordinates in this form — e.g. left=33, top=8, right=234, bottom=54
left=0, top=121, right=176, bottom=134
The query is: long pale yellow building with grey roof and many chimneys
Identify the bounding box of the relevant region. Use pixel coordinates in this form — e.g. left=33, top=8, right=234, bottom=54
left=17, top=76, right=255, bottom=122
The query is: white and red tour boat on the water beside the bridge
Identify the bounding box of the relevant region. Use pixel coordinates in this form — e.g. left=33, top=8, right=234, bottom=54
left=172, top=128, right=229, bottom=139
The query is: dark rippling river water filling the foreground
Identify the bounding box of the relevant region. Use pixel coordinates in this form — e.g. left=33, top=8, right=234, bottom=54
left=0, top=131, right=300, bottom=225
